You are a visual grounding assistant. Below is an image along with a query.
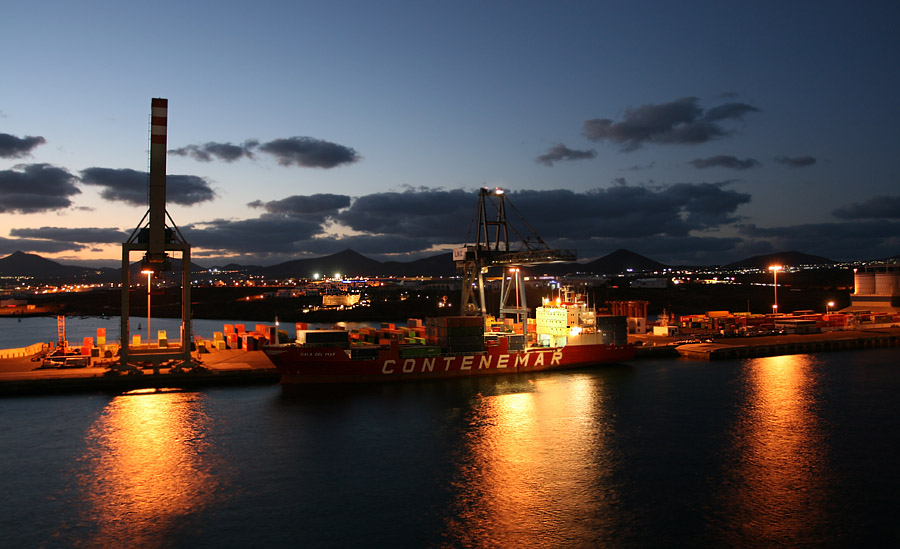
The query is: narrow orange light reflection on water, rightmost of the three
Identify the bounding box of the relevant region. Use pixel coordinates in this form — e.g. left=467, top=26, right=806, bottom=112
left=721, top=355, right=828, bottom=546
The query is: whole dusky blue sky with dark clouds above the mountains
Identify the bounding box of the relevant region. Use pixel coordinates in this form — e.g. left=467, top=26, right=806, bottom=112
left=0, top=0, right=900, bottom=266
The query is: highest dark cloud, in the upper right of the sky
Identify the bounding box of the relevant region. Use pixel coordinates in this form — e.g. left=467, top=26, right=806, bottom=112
left=584, top=97, right=759, bottom=152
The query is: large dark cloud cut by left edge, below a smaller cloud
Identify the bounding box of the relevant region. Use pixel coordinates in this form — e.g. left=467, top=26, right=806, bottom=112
left=0, top=164, right=81, bottom=213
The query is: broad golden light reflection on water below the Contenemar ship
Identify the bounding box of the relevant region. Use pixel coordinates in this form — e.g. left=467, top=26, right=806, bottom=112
left=445, top=375, right=617, bottom=547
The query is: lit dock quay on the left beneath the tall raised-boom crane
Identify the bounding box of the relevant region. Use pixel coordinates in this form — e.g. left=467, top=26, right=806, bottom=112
left=0, top=349, right=281, bottom=397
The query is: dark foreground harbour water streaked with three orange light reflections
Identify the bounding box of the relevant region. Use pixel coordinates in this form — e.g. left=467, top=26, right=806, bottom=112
left=0, top=319, right=900, bottom=547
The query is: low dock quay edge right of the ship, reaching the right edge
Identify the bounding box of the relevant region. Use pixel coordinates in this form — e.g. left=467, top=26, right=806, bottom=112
left=675, top=328, right=900, bottom=360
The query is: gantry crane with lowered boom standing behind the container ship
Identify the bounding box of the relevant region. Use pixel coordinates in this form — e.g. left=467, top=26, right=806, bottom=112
left=453, top=187, right=577, bottom=328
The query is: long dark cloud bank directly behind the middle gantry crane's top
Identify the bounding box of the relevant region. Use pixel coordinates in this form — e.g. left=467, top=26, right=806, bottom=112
left=335, top=182, right=750, bottom=243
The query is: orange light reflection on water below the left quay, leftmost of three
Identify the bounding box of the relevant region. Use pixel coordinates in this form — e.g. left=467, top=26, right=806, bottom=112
left=80, top=390, right=229, bottom=546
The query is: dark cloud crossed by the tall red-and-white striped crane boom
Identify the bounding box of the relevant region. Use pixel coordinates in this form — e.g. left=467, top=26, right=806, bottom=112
left=81, top=168, right=216, bottom=206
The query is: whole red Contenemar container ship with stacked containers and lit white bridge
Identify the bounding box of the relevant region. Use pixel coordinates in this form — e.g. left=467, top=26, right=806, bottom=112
left=263, top=293, right=635, bottom=385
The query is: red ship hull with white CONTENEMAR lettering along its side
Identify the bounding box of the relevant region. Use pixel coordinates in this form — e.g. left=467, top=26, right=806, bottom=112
left=264, top=344, right=635, bottom=384
